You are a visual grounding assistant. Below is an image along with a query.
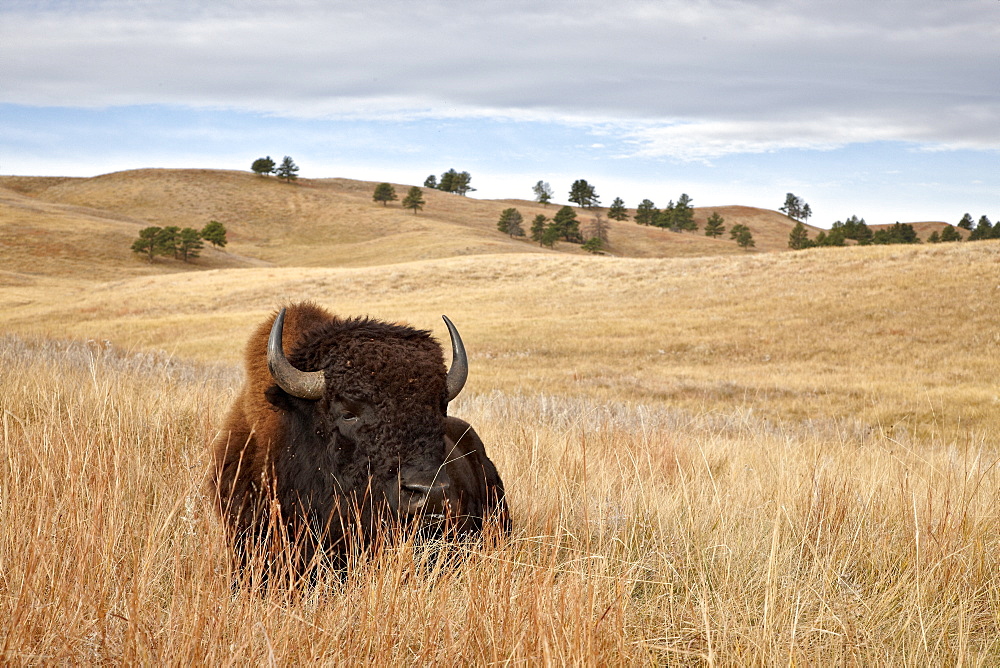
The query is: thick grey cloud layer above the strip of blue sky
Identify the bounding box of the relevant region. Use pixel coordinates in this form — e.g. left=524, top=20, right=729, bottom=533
left=0, top=0, right=1000, bottom=158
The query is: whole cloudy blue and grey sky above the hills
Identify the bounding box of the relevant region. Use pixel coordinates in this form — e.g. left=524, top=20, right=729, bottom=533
left=0, top=0, right=1000, bottom=227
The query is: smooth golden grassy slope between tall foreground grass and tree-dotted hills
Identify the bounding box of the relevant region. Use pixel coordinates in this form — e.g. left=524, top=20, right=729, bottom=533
left=0, top=242, right=1000, bottom=438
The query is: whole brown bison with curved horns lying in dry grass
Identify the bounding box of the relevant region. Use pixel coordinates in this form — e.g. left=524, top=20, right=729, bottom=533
left=208, top=303, right=510, bottom=578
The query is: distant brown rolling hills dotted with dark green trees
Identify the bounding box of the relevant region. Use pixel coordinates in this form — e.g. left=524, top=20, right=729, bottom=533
left=0, top=169, right=844, bottom=279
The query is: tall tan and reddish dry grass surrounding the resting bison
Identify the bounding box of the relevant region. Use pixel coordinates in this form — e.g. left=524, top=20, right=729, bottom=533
left=0, top=336, right=1000, bottom=665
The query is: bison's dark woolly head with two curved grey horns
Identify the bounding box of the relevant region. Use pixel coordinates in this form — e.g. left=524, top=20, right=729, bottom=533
left=266, top=309, right=468, bottom=524
